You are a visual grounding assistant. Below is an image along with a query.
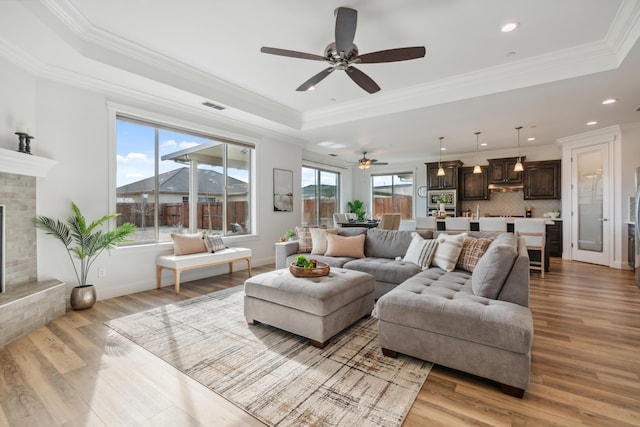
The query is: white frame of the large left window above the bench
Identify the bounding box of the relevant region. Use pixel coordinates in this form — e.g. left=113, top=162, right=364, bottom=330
left=107, top=102, right=259, bottom=247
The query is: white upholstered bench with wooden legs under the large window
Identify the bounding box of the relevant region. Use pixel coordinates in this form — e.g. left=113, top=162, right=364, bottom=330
left=156, top=248, right=251, bottom=294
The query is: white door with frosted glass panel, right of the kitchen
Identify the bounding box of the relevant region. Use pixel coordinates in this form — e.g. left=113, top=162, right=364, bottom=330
left=571, top=143, right=611, bottom=265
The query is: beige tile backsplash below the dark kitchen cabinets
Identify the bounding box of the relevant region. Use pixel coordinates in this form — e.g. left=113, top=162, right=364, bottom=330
left=458, top=191, right=562, bottom=218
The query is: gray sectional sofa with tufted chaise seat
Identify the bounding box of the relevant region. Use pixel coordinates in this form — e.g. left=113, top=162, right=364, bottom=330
left=276, top=228, right=533, bottom=397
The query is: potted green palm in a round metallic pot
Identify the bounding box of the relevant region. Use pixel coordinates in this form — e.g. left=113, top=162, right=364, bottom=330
left=35, top=202, right=136, bottom=310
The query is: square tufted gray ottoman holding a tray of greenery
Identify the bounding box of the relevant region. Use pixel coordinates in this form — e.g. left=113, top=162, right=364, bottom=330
left=244, top=268, right=376, bottom=348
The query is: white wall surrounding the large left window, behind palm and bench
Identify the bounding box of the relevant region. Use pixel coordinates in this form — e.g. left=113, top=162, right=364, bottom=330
left=23, top=79, right=301, bottom=299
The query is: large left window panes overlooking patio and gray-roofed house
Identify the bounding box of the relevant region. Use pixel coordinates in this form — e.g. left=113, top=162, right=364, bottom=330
left=116, top=116, right=253, bottom=243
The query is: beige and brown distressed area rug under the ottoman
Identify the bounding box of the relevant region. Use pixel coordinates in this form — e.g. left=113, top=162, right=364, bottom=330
left=106, top=286, right=432, bottom=427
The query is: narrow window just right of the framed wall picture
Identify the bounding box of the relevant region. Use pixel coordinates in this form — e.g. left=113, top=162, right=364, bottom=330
left=302, top=167, right=340, bottom=227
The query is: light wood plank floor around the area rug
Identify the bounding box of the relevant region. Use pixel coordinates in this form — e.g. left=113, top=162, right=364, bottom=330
left=0, top=259, right=640, bottom=427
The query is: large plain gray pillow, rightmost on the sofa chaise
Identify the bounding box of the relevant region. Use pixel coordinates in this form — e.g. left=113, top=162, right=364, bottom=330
left=471, top=244, right=518, bottom=299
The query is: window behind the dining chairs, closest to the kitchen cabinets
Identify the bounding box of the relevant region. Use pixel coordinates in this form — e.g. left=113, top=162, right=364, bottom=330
left=371, top=172, right=413, bottom=220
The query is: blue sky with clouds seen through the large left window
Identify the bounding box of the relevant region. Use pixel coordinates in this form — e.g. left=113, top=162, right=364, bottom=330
left=116, top=120, right=248, bottom=187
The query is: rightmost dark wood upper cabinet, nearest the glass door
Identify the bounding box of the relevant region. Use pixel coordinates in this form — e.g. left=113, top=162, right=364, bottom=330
left=524, top=160, right=561, bottom=200
